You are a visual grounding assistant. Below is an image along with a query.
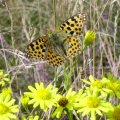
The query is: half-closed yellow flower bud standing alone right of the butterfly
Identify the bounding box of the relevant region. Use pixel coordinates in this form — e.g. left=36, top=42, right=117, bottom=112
left=84, top=31, right=96, bottom=47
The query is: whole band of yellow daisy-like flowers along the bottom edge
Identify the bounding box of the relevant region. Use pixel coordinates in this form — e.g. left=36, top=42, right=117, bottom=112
left=0, top=69, right=120, bottom=120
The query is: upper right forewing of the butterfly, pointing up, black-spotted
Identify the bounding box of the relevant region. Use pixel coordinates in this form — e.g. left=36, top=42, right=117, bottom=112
left=60, top=13, right=86, bottom=35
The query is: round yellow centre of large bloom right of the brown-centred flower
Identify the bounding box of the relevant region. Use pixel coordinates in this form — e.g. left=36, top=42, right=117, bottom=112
left=87, top=96, right=100, bottom=108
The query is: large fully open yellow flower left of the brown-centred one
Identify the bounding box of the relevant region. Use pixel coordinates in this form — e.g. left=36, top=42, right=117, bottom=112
left=25, top=83, right=58, bottom=111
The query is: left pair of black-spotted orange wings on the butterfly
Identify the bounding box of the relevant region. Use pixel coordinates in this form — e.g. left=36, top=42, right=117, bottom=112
left=25, top=36, right=64, bottom=67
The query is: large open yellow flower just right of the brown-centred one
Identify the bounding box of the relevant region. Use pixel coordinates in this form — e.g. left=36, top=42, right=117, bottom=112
left=76, top=89, right=111, bottom=120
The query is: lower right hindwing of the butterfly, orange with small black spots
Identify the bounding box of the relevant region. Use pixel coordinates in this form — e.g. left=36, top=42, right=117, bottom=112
left=64, top=36, right=82, bottom=58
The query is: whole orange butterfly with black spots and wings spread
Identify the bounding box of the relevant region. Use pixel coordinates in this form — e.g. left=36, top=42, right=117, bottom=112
left=25, top=13, right=86, bottom=67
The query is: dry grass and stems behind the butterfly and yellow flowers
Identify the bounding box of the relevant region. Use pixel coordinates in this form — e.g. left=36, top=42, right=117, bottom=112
left=0, top=0, right=120, bottom=119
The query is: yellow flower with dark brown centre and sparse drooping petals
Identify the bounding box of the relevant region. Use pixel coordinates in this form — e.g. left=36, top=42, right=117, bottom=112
left=52, top=89, right=76, bottom=118
